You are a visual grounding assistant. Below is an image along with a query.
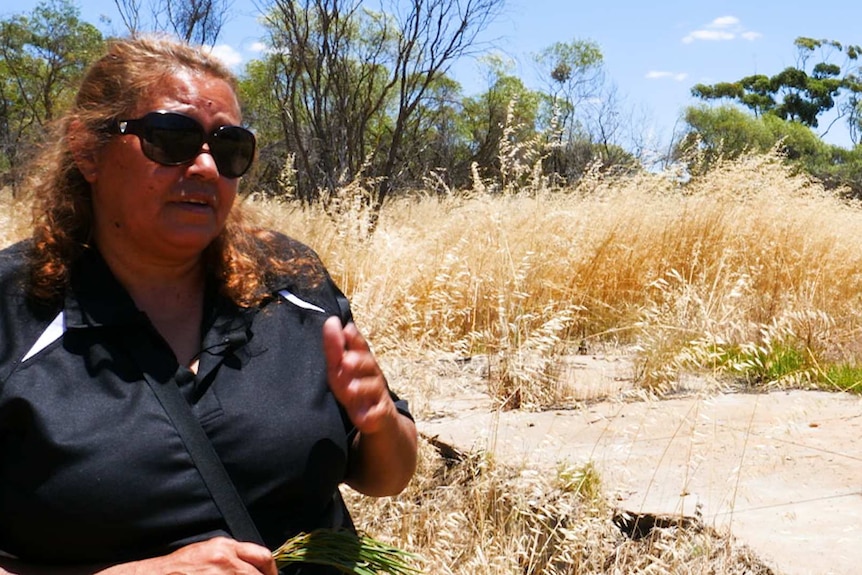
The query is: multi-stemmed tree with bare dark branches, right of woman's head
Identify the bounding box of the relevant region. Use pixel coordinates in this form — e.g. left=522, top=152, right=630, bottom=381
left=255, top=0, right=502, bottom=207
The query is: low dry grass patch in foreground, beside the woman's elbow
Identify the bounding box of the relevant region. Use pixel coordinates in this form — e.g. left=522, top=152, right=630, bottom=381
left=345, top=441, right=774, bottom=575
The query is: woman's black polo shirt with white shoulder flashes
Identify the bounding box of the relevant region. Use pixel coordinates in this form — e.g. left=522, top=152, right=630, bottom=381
left=0, top=236, right=409, bottom=564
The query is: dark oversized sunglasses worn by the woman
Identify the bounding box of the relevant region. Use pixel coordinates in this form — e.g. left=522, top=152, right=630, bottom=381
left=110, top=111, right=255, bottom=178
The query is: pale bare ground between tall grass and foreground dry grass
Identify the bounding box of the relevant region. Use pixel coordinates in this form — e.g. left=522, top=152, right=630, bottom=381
left=410, top=355, right=862, bottom=575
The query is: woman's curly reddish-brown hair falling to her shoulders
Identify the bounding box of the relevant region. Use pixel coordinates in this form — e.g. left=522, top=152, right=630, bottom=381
left=29, top=35, right=317, bottom=306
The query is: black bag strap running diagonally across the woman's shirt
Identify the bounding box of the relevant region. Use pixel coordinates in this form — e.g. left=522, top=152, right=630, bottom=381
left=125, top=337, right=264, bottom=545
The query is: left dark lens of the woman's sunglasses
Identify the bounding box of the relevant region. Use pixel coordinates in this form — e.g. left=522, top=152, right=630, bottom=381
left=143, top=114, right=208, bottom=165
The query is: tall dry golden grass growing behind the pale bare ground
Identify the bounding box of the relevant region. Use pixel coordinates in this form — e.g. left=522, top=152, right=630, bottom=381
left=248, top=156, right=862, bottom=400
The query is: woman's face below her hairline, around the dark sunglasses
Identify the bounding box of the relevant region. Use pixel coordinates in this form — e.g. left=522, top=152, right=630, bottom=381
left=81, top=72, right=240, bottom=261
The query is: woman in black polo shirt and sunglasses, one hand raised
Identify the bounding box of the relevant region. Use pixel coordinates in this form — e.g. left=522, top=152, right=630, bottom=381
left=0, top=38, right=416, bottom=575
